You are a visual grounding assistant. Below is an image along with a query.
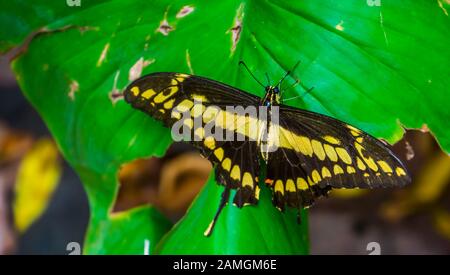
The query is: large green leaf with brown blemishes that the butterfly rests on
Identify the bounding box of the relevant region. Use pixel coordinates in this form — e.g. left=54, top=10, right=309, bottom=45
left=0, top=0, right=450, bottom=253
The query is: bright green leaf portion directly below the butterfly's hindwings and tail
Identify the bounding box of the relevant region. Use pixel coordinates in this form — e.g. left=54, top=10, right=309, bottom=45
left=156, top=174, right=308, bottom=255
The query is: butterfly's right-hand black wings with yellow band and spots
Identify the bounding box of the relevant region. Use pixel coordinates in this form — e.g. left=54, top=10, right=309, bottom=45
left=267, top=105, right=410, bottom=209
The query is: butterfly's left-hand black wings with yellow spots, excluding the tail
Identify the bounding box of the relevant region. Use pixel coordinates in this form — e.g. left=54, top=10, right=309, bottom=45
left=124, top=73, right=259, bottom=207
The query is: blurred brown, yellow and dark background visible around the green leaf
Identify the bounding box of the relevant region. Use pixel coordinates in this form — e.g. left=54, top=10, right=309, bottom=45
left=0, top=57, right=450, bottom=254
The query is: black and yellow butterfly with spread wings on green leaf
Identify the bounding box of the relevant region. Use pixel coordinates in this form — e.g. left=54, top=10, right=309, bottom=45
left=124, top=66, right=410, bottom=235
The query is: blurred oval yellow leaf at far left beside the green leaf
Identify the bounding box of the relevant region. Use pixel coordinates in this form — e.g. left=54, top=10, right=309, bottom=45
left=13, top=138, right=61, bottom=233
